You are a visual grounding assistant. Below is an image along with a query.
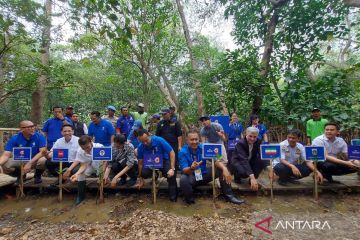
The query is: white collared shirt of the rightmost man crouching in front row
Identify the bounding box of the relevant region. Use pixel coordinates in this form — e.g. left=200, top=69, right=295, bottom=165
left=312, top=134, right=348, bottom=157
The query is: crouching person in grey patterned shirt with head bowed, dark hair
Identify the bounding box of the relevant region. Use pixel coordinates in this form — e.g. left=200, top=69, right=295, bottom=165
left=104, top=134, right=137, bottom=188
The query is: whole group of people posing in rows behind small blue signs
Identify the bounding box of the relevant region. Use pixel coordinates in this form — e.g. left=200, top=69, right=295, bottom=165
left=0, top=106, right=359, bottom=204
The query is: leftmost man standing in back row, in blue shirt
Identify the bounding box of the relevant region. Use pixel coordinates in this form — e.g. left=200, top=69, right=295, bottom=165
left=42, top=106, right=73, bottom=150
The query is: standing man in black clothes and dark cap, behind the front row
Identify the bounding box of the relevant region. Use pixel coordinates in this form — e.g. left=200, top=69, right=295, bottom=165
left=156, top=108, right=182, bottom=168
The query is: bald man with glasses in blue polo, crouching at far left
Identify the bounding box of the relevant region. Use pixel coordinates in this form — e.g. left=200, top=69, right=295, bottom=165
left=0, top=120, right=46, bottom=182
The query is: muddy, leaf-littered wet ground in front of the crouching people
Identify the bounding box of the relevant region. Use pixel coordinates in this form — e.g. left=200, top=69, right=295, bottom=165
left=0, top=189, right=360, bottom=240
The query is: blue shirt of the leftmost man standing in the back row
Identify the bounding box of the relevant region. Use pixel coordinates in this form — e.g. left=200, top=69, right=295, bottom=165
left=42, top=117, right=73, bottom=149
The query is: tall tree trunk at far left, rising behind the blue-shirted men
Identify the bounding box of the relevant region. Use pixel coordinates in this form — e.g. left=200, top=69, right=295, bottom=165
left=31, top=0, right=52, bottom=124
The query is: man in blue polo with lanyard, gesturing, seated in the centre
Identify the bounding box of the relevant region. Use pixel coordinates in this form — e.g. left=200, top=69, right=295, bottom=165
left=179, top=130, right=244, bottom=204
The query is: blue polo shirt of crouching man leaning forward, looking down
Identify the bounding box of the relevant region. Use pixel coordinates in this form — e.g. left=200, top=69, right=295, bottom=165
left=138, top=136, right=173, bottom=161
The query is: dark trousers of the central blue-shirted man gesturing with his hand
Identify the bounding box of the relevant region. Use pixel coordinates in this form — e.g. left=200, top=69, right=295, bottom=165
left=180, top=167, right=233, bottom=200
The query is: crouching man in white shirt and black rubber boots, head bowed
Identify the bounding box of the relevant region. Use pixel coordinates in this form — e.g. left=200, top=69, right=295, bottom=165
left=70, top=135, right=103, bottom=205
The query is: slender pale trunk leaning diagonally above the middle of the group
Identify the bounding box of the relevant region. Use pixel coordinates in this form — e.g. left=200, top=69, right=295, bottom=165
left=176, top=0, right=205, bottom=117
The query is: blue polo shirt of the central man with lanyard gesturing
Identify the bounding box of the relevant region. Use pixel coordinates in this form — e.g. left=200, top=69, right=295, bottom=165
left=178, top=144, right=207, bottom=174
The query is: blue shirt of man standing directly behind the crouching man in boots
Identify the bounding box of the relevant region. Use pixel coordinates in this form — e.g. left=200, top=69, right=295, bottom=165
left=88, top=119, right=115, bottom=146
